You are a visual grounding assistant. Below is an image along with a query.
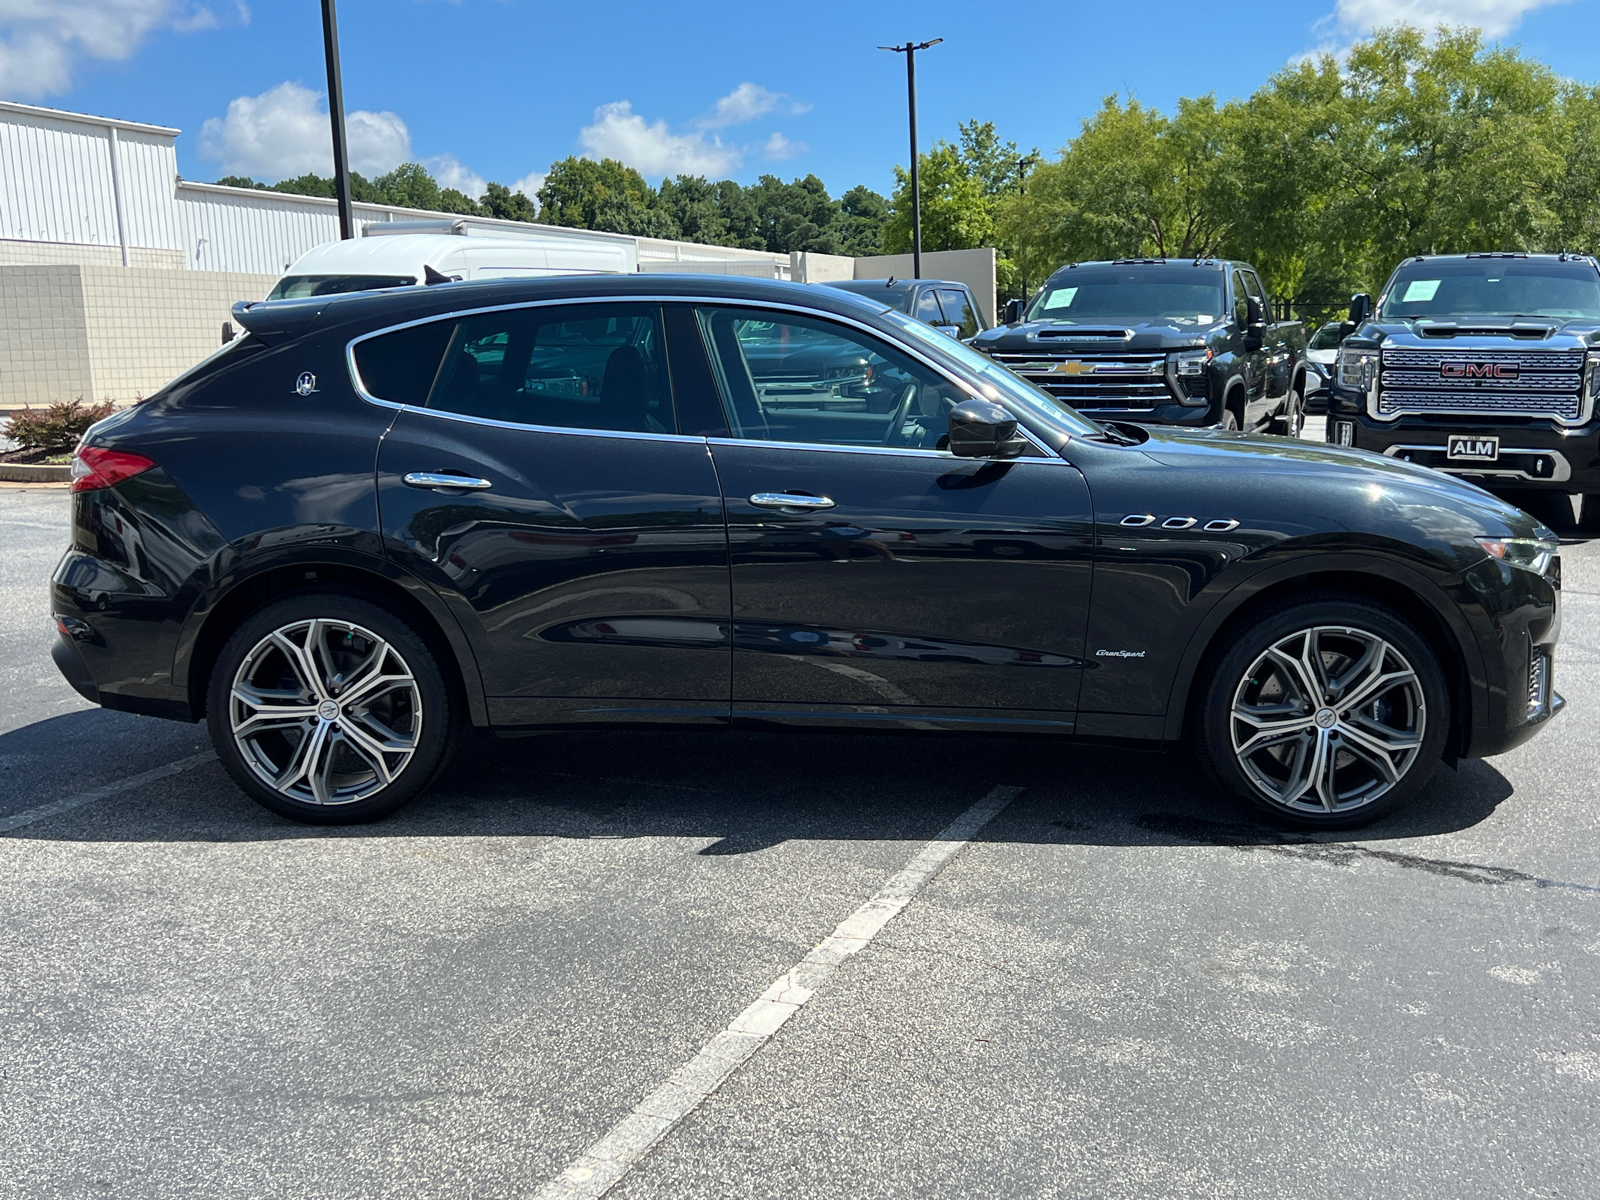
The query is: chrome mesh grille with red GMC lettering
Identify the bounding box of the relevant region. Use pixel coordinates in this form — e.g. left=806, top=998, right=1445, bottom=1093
left=1376, top=347, right=1584, bottom=421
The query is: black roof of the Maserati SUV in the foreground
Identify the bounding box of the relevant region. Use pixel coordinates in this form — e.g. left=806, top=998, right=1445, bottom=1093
left=234, top=272, right=890, bottom=341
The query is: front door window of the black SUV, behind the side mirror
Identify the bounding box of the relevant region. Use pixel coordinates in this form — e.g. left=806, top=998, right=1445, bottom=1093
left=699, top=309, right=968, bottom=450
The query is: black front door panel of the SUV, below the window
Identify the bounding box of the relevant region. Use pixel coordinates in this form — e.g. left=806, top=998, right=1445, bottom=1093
left=712, top=440, right=1093, bottom=726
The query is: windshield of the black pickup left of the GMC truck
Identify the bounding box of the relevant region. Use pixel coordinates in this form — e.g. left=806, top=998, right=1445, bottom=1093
left=1024, top=267, right=1227, bottom=325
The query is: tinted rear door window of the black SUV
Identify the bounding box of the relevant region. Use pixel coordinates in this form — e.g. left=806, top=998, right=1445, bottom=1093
left=429, top=304, right=677, bottom=434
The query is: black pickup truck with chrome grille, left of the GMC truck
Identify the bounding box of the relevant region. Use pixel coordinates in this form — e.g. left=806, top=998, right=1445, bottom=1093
left=971, top=259, right=1306, bottom=437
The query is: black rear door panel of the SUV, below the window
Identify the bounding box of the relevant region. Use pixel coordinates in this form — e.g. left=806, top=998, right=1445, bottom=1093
left=378, top=408, right=730, bottom=715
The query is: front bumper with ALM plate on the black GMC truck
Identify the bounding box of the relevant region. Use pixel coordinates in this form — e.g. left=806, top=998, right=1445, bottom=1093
left=1325, top=389, right=1600, bottom=493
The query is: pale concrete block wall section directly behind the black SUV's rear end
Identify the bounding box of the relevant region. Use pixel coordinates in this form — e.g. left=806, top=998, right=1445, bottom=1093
left=80, top=267, right=277, bottom=400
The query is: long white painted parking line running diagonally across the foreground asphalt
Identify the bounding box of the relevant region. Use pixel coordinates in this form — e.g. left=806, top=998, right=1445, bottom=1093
left=536, top=786, right=1022, bottom=1200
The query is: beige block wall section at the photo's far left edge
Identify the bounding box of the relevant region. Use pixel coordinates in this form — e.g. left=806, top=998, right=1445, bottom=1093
left=0, top=264, right=94, bottom=408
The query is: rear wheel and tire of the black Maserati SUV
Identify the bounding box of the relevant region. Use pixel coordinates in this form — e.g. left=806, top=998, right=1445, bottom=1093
left=206, top=592, right=458, bottom=826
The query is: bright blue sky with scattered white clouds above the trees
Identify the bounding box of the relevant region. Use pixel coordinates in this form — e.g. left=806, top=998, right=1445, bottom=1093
left=0, top=0, right=1600, bottom=195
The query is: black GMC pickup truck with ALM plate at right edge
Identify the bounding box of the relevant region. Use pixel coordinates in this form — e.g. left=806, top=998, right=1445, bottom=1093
left=1326, top=253, right=1600, bottom=530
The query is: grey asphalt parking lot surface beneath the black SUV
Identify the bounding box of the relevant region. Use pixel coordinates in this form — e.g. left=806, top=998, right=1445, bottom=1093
left=0, top=464, right=1600, bottom=1200
